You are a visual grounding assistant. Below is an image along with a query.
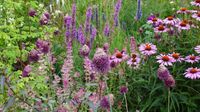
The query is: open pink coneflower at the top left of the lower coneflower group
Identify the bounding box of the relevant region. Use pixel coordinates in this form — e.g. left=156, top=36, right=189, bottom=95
left=139, top=43, right=157, bottom=56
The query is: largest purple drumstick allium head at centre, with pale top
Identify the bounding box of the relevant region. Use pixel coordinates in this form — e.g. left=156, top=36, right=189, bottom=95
left=93, top=48, right=110, bottom=73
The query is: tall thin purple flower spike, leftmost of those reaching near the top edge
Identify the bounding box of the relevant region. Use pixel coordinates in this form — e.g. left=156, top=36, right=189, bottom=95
left=72, top=3, right=76, bottom=38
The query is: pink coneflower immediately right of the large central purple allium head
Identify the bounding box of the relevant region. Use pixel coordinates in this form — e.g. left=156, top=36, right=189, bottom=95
left=111, top=51, right=128, bottom=63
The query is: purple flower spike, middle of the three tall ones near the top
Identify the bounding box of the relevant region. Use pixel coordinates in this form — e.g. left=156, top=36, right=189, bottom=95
left=85, top=7, right=92, bottom=33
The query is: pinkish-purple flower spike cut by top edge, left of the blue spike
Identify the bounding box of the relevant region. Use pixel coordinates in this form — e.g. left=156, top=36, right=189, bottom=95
left=114, top=0, right=122, bottom=26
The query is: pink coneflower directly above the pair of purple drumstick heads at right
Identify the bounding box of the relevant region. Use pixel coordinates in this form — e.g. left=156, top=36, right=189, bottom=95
left=156, top=54, right=175, bottom=66
